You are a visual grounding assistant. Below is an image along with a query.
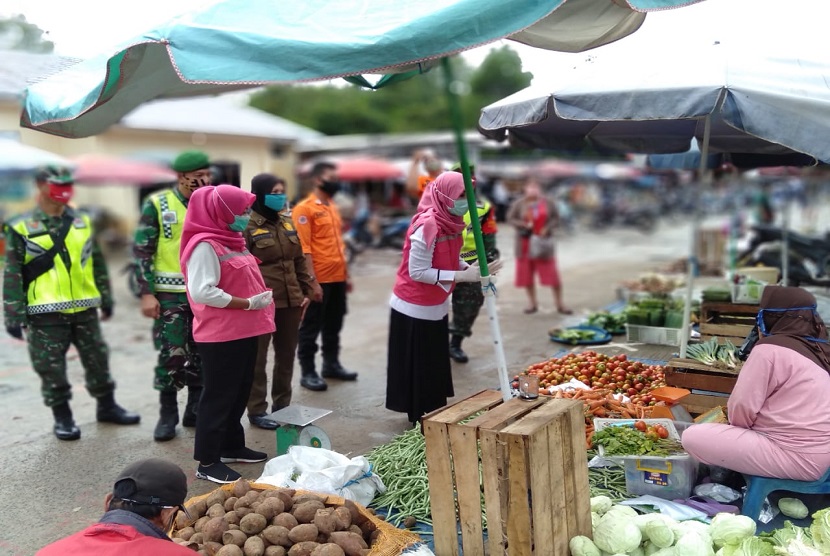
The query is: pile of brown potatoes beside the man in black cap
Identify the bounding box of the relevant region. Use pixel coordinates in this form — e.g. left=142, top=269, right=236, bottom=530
left=176, top=479, right=380, bottom=556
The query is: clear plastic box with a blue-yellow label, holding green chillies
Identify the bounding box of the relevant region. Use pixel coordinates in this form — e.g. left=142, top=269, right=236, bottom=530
left=625, top=455, right=697, bottom=500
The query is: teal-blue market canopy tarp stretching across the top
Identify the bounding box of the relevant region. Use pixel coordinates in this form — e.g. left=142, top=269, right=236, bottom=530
left=21, top=0, right=700, bottom=137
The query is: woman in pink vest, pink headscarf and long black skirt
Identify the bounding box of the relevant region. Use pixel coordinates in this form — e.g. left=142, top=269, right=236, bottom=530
left=386, top=172, right=501, bottom=423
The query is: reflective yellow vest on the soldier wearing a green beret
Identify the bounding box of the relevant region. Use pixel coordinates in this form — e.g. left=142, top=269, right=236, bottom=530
left=150, top=189, right=187, bottom=293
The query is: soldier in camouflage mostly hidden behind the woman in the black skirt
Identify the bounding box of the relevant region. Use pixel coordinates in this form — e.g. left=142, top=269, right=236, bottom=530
left=450, top=164, right=499, bottom=363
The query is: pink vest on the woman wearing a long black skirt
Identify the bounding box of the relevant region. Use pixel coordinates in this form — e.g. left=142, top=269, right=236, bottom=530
left=392, top=225, right=464, bottom=306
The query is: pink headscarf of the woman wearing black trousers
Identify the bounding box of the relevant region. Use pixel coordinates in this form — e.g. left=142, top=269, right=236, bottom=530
left=179, top=185, right=256, bottom=267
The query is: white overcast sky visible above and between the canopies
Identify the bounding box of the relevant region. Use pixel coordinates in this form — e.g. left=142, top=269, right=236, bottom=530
left=0, top=0, right=830, bottom=89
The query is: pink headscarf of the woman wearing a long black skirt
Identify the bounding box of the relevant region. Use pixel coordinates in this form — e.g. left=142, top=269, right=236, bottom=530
left=410, top=172, right=472, bottom=245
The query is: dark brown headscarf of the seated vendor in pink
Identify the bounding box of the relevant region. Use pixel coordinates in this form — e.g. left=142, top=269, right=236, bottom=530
left=758, top=286, right=830, bottom=373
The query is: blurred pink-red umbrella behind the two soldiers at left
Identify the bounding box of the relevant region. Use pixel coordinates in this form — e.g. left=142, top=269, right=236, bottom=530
left=74, top=154, right=177, bottom=185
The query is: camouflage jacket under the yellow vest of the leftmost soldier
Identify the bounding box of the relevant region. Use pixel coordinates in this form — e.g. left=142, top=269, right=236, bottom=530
left=3, top=207, right=113, bottom=326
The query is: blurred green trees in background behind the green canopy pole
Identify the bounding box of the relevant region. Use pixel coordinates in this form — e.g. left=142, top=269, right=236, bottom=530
left=251, top=46, right=533, bottom=135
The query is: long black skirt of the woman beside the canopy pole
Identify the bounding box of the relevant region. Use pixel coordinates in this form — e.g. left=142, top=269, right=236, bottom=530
left=386, top=309, right=455, bottom=423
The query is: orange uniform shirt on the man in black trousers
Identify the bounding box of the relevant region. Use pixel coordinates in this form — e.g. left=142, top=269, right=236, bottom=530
left=291, top=193, right=348, bottom=284
